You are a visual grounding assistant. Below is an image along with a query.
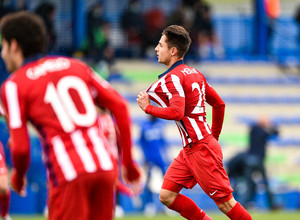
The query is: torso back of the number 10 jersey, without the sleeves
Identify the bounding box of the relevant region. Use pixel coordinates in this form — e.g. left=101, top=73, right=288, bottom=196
left=6, top=57, right=113, bottom=184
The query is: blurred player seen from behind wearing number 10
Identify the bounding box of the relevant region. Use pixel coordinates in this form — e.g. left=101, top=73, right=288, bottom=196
left=0, top=11, right=140, bottom=220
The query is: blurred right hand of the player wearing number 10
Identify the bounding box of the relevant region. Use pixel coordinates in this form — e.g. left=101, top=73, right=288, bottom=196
left=122, top=163, right=145, bottom=195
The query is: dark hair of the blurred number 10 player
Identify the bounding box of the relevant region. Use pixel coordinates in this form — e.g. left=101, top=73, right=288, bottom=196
left=0, top=11, right=46, bottom=58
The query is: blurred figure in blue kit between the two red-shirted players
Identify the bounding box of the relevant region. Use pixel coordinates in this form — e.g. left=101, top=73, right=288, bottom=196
left=139, top=115, right=170, bottom=215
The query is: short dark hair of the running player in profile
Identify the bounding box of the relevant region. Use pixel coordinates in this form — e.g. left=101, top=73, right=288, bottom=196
left=162, top=25, right=192, bottom=58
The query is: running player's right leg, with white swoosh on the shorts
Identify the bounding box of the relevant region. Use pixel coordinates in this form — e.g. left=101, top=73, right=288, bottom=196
left=184, top=136, right=252, bottom=220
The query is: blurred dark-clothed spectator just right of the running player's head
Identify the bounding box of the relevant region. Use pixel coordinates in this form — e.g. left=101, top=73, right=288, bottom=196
left=192, top=1, right=224, bottom=58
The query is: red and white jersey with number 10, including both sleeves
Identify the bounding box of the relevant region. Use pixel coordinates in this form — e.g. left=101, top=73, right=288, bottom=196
left=1, top=57, right=132, bottom=186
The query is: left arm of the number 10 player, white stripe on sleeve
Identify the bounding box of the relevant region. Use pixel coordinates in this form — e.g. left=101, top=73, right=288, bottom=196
left=1, top=81, right=30, bottom=194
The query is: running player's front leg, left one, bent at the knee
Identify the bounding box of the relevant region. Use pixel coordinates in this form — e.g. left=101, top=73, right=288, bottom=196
left=159, top=152, right=211, bottom=220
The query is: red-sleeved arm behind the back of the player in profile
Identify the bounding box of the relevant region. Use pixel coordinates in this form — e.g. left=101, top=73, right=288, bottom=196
left=205, top=83, right=225, bottom=140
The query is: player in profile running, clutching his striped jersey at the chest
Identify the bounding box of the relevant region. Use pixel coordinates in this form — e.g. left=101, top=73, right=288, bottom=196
left=137, top=25, right=252, bottom=220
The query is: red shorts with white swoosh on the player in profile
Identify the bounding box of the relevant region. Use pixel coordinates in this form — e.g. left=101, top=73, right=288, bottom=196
left=162, top=135, right=233, bottom=204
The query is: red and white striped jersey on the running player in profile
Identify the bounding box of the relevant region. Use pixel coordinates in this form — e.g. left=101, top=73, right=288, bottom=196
left=146, top=60, right=225, bottom=147
